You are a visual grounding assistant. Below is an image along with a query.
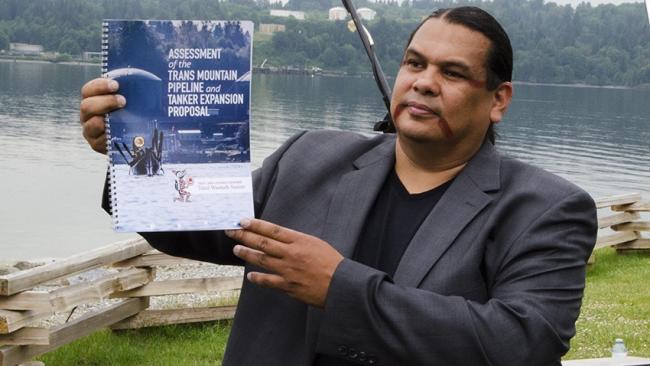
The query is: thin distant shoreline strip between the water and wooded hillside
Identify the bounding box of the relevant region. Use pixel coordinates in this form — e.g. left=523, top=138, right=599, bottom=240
left=0, top=57, right=650, bottom=90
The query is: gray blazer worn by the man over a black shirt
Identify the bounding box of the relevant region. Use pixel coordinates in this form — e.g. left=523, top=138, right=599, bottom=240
left=143, top=131, right=597, bottom=366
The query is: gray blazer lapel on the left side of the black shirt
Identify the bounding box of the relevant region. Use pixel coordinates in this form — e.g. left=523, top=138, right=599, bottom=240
left=322, top=139, right=395, bottom=258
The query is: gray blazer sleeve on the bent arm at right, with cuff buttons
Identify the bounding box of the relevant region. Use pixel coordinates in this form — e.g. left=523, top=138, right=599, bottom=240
left=317, top=191, right=597, bottom=366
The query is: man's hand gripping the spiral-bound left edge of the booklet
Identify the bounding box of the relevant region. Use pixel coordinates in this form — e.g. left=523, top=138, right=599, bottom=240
left=79, top=78, right=126, bottom=154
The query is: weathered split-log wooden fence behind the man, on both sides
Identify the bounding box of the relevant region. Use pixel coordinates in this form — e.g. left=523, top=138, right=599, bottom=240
left=0, top=194, right=650, bottom=366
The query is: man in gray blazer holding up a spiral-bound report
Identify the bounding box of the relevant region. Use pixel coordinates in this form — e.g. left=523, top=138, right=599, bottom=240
left=81, top=7, right=596, bottom=366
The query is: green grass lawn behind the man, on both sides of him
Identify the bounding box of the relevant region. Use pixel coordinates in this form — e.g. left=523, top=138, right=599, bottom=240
left=40, top=249, right=650, bottom=366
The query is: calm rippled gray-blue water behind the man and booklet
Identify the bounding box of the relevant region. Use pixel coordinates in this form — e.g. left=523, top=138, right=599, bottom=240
left=0, top=62, right=650, bottom=261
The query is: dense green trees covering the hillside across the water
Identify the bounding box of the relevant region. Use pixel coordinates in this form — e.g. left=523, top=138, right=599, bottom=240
left=0, top=0, right=650, bottom=86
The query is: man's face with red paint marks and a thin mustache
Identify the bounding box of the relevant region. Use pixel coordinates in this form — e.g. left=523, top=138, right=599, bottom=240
left=391, top=18, right=509, bottom=149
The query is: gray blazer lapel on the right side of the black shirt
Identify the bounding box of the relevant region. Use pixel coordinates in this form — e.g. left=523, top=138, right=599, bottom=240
left=394, top=143, right=499, bottom=287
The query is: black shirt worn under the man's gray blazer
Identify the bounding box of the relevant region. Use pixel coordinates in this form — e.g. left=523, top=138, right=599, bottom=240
left=314, top=170, right=451, bottom=366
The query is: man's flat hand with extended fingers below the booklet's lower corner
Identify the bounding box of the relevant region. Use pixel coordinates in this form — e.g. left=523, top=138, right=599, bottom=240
left=226, top=219, right=343, bottom=308
